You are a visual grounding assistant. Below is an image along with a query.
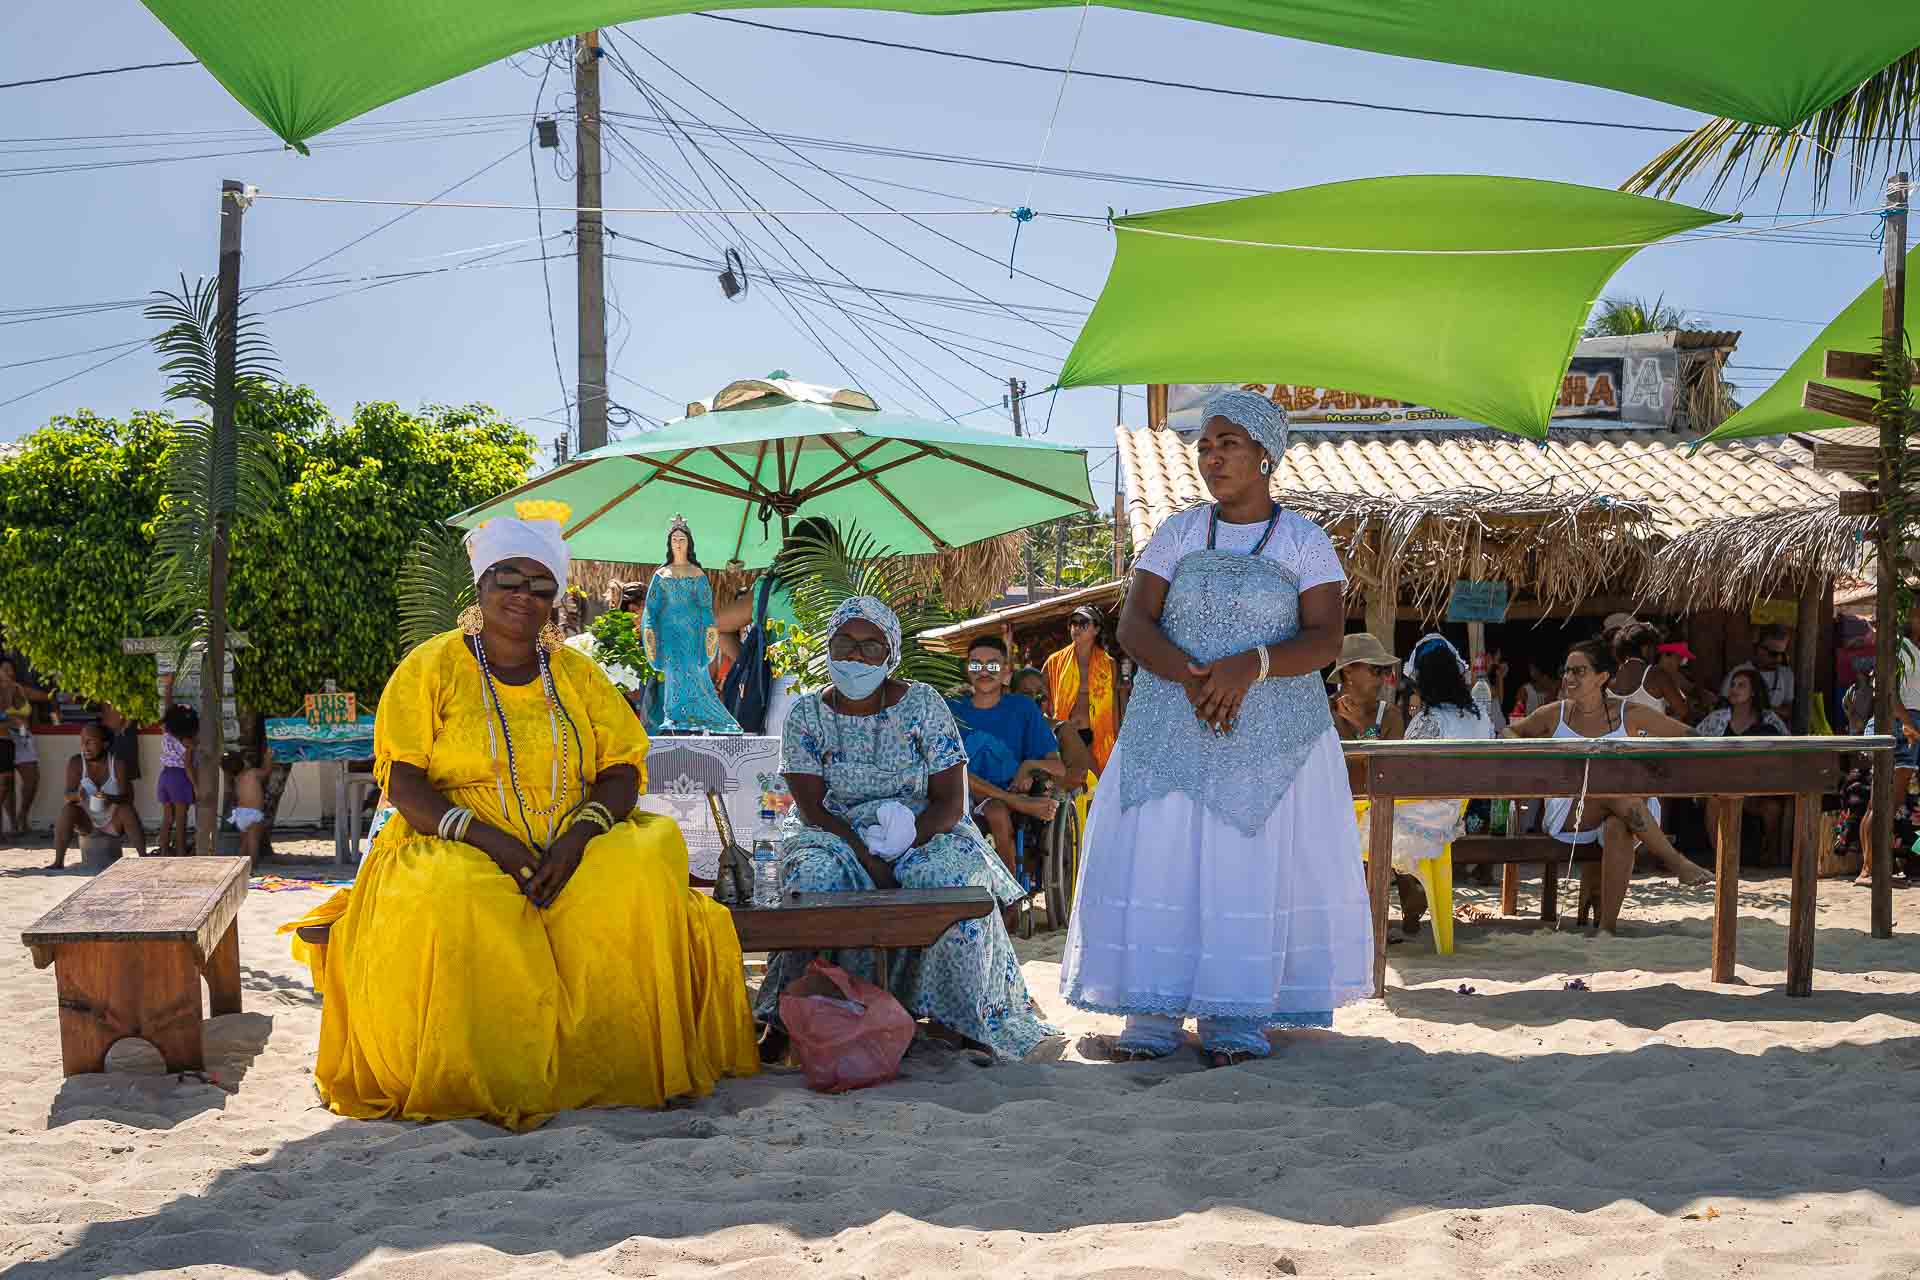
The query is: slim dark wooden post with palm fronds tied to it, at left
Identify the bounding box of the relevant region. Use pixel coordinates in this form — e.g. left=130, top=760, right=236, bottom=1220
left=196, top=178, right=250, bottom=854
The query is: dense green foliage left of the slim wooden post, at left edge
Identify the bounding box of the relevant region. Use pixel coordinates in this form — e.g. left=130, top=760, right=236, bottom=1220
left=0, top=411, right=175, bottom=722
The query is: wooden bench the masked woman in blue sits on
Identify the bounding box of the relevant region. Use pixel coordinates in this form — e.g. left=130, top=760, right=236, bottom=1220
left=296, top=885, right=995, bottom=984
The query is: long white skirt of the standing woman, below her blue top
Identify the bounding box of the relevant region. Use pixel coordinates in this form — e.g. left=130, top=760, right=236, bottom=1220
left=1060, top=729, right=1373, bottom=1027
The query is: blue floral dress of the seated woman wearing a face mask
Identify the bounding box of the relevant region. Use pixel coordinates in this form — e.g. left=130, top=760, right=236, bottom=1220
left=755, top=683, right=1058, bottom=1057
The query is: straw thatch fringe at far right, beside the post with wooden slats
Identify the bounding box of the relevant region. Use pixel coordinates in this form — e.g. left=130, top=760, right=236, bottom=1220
left=1640, top=507, right=1874, bottom=612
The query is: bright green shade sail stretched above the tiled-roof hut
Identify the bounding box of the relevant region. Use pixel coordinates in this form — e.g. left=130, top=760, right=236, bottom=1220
left=1060, top=177, right=1726, bottom=438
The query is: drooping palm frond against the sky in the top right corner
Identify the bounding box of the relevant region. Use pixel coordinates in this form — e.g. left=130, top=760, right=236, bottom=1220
left=1620, top=50, right=1920, bottom=209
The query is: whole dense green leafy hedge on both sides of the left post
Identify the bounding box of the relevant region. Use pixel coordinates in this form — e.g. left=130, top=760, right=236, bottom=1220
left=0, top=386, right=534, bottom=722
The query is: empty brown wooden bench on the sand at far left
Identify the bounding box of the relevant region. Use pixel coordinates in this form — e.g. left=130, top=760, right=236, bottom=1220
left=19, top=858, right=248, bottom=1075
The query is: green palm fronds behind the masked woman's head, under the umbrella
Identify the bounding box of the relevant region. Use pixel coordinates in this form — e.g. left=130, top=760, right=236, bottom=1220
left=781, top=524, right=962, bottom=691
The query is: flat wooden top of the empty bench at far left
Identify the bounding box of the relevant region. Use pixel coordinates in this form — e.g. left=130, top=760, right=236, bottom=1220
left=21, top=858, right=250, bottom=963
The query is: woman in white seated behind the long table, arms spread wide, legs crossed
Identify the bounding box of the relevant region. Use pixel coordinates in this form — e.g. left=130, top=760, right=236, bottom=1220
left=1505, top=641, right=1713, bottom=933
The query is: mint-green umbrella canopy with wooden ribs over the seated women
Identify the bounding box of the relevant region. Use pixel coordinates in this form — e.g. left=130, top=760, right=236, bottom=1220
left=453, top=401, right=1092, bottom=568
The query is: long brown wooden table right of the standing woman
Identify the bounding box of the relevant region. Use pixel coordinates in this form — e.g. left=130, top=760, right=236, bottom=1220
left=1342, top=737, right=1893, bottom=996
